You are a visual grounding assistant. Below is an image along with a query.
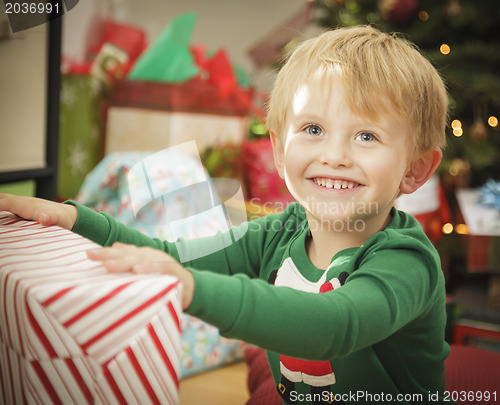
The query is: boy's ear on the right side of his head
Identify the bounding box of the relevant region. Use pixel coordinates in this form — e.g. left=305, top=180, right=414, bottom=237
left=399, top=148, right=443, bottom=194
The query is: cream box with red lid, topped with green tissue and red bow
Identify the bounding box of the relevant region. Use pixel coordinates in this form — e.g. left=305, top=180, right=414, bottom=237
left=105, top=13, right=256, bottom=158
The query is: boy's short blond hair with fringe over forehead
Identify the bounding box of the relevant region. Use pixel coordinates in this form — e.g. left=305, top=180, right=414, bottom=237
left=267, top=26, right=448, bottom=153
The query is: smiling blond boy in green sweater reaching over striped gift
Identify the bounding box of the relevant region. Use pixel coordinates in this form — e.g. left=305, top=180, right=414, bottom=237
left=0, top=27, right=449, bottom=404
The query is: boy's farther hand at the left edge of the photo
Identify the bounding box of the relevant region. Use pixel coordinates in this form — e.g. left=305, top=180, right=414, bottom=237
left=0, top=193, right=78, bottom=230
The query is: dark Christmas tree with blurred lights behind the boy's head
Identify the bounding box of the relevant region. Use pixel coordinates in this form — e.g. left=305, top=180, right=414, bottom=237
left=315, top=0, right=500, bottom=187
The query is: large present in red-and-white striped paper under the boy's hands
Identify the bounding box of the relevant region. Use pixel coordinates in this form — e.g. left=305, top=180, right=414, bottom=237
left=0, top=212, right=182, bottom=405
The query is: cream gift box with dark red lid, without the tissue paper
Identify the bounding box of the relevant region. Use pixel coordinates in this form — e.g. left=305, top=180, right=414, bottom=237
left=105, top=80, right=251, bottom=154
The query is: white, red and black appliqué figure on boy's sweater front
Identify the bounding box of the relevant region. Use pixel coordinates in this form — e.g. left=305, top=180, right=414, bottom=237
left=268, top=257, right=349, bottom=404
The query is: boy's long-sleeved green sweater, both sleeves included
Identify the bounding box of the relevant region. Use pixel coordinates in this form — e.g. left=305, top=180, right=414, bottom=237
left=69, top=203, right=449, bottom=404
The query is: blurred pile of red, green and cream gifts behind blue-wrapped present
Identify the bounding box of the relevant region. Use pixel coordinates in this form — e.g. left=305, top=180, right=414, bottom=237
left=58, top=14, right=291, bottom=211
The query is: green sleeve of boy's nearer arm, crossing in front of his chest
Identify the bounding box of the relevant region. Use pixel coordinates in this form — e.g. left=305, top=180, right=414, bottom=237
left=188, top=238, right=445, bottom=360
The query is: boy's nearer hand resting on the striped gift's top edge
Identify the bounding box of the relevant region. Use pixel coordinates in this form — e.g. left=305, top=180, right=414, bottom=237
left=87, top=242, right=194, bottom=309
